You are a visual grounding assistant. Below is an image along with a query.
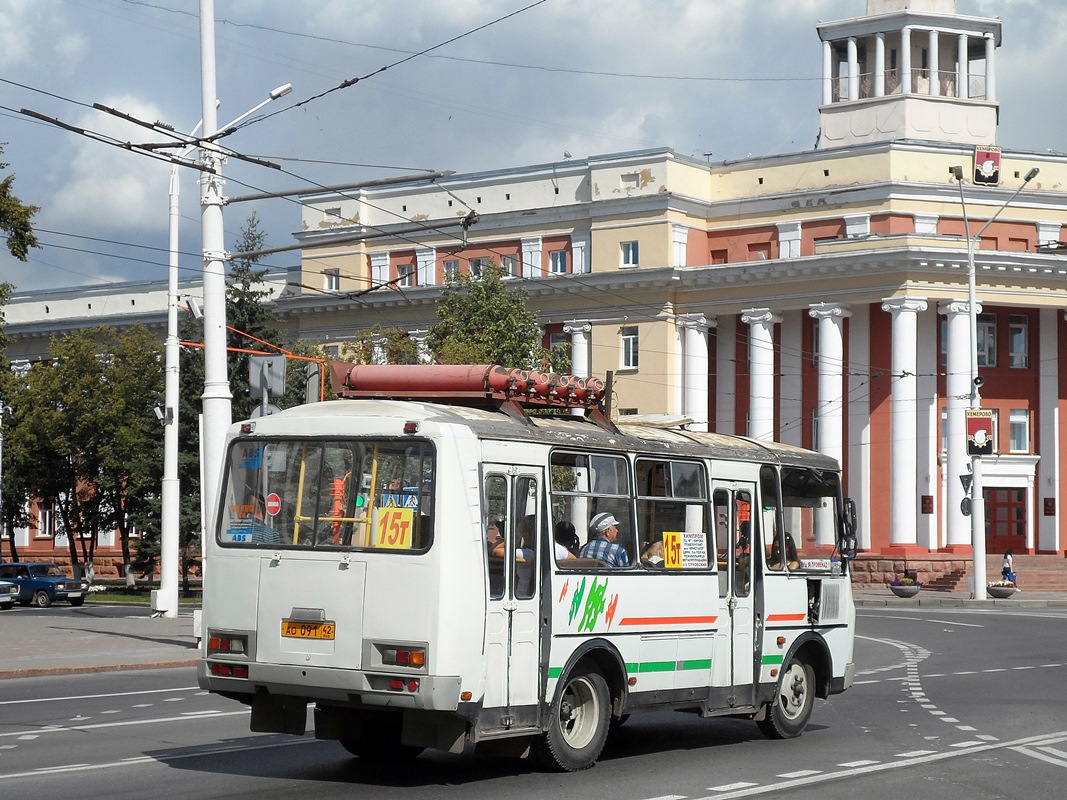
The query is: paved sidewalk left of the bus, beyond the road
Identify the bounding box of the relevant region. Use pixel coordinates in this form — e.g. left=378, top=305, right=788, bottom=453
left=0, top=602, right=198, bottom=679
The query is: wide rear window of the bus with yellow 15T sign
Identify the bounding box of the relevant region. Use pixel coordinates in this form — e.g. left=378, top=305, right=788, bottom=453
left=219, top=439, right=435, bottom=553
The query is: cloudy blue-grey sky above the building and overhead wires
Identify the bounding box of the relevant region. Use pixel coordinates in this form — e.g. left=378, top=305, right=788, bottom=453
left=0, top=0, right=1067, bottom=290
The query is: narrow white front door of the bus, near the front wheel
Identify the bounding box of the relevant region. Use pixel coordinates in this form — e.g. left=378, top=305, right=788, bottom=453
left=712, top=481, right=762, bottom=707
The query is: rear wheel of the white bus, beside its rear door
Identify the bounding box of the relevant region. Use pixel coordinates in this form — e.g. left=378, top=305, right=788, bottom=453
left=537, top=668, right=611, bottom=772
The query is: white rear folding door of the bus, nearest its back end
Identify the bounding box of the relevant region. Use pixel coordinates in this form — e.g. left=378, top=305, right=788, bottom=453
left=482, top=464, right=543, bottom=726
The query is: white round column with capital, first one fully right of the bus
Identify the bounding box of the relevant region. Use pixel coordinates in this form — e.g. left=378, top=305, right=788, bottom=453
left=881, top=298, right=926, bottom=550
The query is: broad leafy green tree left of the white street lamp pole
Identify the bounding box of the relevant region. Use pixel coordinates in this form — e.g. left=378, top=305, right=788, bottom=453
left=7, top=326, right=163, bottom=574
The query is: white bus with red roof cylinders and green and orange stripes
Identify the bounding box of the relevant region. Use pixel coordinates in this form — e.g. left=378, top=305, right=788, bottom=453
left=197, top=365, right=855, bottom=770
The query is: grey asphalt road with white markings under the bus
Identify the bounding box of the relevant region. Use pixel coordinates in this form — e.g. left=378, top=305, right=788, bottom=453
left=0, top=607, right=1067, bottom=800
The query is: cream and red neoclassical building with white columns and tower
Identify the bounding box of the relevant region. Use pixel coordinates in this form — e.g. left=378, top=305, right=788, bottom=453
left=2, top=0, right=1067, bottom=556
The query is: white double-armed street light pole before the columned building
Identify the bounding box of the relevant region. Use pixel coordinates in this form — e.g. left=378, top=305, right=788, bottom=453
left=952, top=166, right=1040, bottom=599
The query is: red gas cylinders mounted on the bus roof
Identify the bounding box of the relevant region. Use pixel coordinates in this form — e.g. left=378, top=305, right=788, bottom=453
left=330, top=362, right=617, bottom=431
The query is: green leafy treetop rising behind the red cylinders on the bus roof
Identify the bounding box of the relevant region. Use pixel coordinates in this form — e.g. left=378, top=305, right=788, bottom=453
left=426, top=262, right=562, bottom=369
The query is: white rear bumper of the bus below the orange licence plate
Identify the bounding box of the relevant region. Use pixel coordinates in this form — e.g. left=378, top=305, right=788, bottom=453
left=196, top=659, right=461, bottom=711
